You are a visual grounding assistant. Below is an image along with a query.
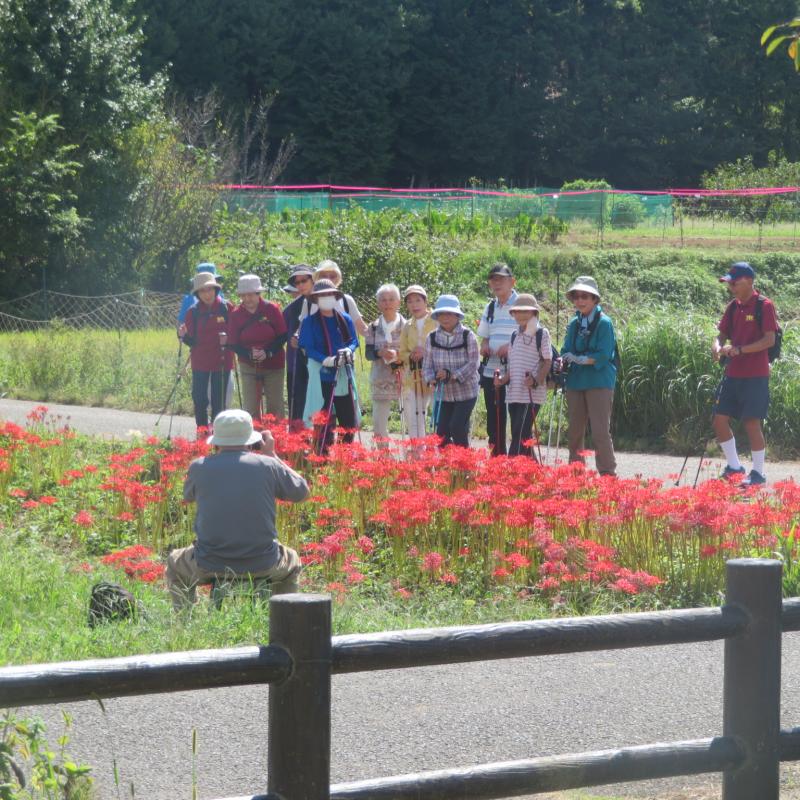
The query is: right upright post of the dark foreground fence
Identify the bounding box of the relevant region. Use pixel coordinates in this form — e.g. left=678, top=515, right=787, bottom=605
left=722, top=558, right=781, bottom=800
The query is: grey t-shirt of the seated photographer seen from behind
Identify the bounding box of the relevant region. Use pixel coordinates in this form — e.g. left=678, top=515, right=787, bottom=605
left=183, top=450, right=308, bottom=573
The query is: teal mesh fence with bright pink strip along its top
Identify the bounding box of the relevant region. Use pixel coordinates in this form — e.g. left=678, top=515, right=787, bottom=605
left=220, top=184, right=800, bottom=250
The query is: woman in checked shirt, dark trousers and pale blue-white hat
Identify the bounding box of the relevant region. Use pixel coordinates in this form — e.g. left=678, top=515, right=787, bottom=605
left=422, top=294, right=480, bottom=447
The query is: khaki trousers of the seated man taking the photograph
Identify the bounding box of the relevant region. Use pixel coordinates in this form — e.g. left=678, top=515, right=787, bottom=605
left=166, top=542, right=303, bottom=611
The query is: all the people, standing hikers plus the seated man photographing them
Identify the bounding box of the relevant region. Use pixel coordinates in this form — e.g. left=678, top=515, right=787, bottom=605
left=166, top=260, right=781, bottom=609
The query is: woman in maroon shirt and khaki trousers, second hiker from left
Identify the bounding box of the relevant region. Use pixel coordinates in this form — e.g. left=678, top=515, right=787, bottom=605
left=228, top=275, right=286, bottom=419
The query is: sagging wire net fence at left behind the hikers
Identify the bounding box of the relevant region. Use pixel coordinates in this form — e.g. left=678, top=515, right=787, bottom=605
left=0, top=289, right=378, bottom=333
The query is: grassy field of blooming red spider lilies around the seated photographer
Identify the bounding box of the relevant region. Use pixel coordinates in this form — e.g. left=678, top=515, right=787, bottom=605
left=0, top=407, right=800, bottom=663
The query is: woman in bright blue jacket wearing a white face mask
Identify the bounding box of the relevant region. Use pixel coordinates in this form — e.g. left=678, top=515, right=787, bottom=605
left=300, top=279, right=360, bottom=451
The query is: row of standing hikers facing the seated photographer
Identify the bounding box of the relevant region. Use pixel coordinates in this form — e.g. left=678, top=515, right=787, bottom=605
left=173, top=259, right=779, bottom=485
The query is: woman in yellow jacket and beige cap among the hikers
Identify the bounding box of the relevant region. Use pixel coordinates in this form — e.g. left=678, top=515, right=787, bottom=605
left=400, top=284, right=437, bottom=439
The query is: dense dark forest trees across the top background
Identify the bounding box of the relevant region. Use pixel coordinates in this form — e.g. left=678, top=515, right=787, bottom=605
left=135, top=0, right=800, bottom=188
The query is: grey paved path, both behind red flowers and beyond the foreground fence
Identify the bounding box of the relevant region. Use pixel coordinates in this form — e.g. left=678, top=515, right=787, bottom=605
left=0, top=400, right=800, bottom=800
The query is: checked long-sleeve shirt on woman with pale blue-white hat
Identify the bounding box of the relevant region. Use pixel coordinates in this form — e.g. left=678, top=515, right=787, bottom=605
left=422, top=322, right=480, bottom=403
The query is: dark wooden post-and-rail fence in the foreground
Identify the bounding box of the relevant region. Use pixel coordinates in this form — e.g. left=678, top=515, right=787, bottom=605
left=0, top=559, right=800, bottom=800
